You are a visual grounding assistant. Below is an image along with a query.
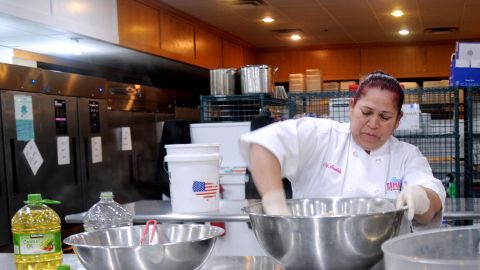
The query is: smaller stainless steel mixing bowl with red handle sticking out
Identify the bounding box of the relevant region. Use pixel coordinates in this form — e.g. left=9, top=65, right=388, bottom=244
left=63, top=224, right=224, bottom=270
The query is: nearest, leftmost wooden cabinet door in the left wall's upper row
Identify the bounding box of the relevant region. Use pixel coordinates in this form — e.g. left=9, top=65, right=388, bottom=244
left=117, top=0, right=160, bottom=53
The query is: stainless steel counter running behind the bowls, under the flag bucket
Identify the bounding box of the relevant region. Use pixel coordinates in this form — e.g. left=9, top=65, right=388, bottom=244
left=65, top=198, right=480, bottom=223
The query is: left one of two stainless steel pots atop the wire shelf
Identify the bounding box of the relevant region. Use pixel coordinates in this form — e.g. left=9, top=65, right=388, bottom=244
left=210, top=68, right=237, bottom=96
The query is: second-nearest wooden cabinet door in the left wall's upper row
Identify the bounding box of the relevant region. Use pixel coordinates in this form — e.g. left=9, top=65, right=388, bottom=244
left=160, top=11, right=195, bottom=60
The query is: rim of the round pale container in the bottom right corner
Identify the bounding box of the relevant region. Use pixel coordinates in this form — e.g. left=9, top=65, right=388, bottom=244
left=382, top=225, right=480, bottom=265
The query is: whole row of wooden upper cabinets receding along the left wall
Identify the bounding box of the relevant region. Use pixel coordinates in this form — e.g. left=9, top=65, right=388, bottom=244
left=116, top=0, right=254, bottom=69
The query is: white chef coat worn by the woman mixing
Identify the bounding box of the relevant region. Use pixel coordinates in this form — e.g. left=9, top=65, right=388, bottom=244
left=240, top=117, right=446, bottom=227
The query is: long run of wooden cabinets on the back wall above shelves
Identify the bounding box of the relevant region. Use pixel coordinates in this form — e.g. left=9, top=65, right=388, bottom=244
left=255, top=42, right=455, bottom=82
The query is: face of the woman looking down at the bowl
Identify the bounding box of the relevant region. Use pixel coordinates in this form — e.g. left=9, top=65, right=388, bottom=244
left=349, top=88, right=402, bottom=151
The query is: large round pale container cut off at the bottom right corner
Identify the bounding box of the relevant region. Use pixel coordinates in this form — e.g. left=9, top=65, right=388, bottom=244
left=382, top=226, right=480, bottom=270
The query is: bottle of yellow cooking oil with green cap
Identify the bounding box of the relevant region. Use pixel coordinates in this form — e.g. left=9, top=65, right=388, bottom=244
left=12, top=194, right=62, bottom=270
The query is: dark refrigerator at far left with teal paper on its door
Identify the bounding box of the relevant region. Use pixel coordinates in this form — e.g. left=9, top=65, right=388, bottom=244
left=1, top=90, right=83, bottom=221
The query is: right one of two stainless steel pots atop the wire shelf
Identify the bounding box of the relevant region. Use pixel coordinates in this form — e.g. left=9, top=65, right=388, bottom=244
left=240, top=65, right=278, bottom=94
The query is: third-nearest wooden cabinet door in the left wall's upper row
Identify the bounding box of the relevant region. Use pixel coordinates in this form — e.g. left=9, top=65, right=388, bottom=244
left=195, top=27, right=222, bottom=69
